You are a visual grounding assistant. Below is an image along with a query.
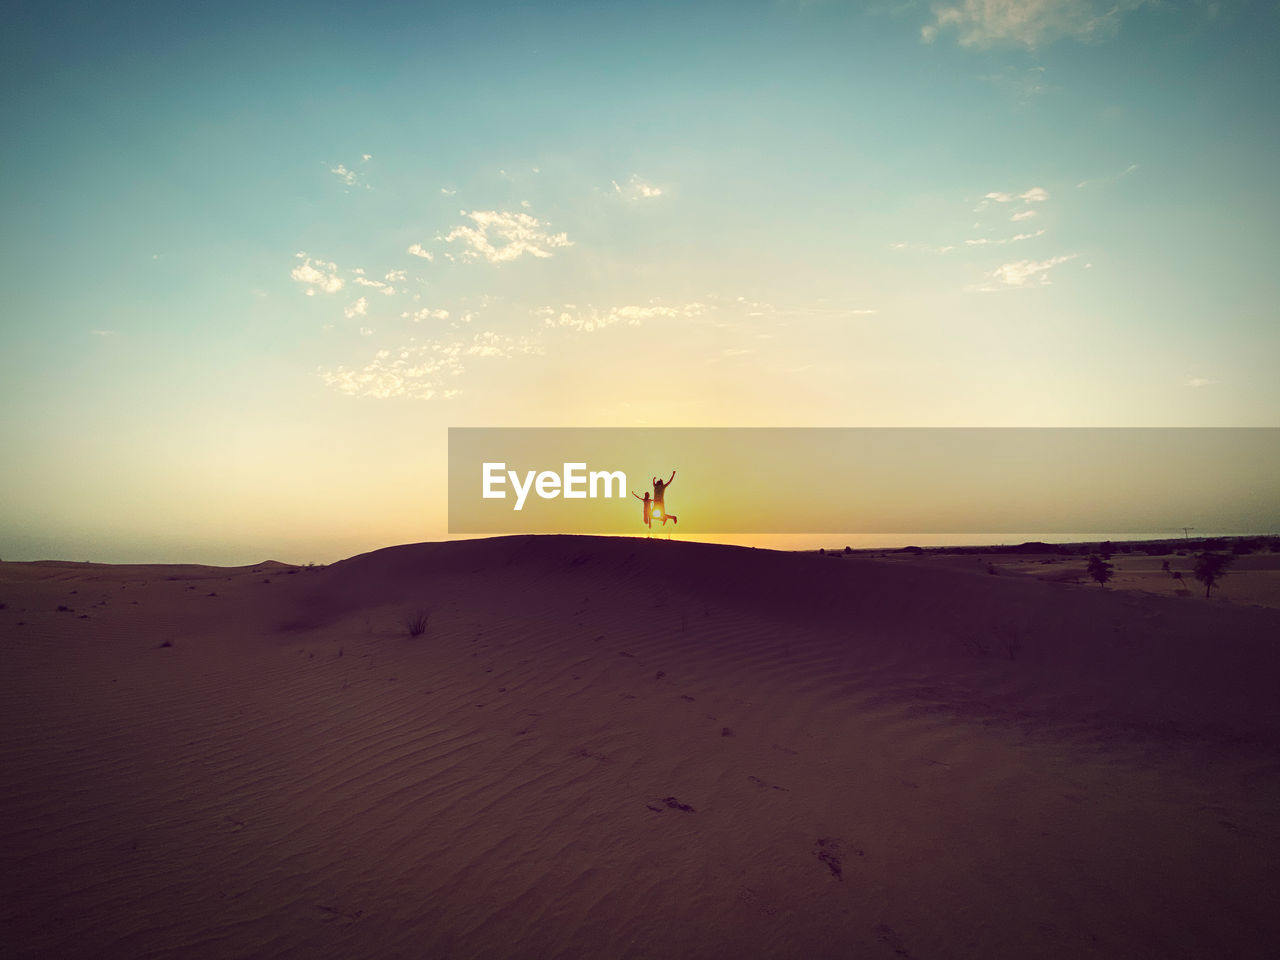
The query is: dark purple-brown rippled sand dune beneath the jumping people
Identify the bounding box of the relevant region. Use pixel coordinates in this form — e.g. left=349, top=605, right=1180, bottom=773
left=0, top=538, right=1280, bottom=960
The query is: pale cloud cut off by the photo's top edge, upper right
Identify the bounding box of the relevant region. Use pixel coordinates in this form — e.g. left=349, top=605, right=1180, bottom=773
left=920, top=0, right=1148, bottom=50
